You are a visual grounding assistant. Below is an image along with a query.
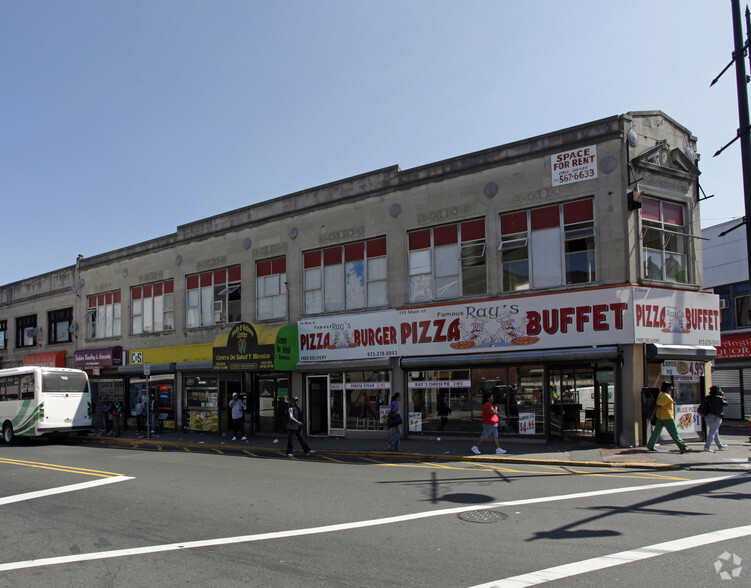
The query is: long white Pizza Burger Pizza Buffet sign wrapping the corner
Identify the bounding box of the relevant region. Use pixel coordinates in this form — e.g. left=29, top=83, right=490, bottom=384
left=298, top=286, right=720, bottom=362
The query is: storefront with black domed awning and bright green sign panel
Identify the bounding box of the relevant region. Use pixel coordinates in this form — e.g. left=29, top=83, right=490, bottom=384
left=213, top=323, right=297, bottom=434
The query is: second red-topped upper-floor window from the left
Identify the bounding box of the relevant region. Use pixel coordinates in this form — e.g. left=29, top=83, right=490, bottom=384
left=130, top=279, right=175, bottom=335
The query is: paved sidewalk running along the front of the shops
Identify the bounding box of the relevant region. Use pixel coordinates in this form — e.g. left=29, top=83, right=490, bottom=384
left=78, top=428, right=751, bottom=473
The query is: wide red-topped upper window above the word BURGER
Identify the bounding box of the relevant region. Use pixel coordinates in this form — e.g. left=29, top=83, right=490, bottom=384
left=303, top=237, right=388, bottom=314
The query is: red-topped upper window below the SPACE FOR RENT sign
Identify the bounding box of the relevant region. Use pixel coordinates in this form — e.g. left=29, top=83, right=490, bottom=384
left=498, top=199, right=596, bottom=292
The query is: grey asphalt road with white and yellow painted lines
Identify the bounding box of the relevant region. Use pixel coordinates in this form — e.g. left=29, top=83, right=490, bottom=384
left=0, top=442, right=751, bottom=588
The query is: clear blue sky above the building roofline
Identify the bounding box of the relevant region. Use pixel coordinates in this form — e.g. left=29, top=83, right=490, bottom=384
left=0, top=0, right=749, bottom=284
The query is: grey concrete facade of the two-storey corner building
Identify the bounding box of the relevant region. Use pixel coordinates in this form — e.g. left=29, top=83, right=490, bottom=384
left=0, top=111, right=724, bottom=445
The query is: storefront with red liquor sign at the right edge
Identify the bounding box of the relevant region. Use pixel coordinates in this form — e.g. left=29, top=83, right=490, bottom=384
left=712, top=333, right=751, bottom=420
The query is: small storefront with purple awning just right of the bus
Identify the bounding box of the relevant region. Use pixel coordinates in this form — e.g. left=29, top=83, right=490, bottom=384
left=73, top=345, right=127, bottom=430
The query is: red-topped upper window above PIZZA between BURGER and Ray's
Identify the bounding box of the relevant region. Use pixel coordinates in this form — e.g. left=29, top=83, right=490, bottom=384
left=408, top=219, right=487, bottom=302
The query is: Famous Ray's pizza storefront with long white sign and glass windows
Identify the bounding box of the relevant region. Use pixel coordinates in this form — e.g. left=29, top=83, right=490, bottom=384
left=298, top=286, right=719, bottom=444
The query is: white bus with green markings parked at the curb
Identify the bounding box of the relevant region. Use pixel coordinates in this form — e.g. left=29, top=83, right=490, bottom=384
left=0, top=366, right=93, bottom=443
